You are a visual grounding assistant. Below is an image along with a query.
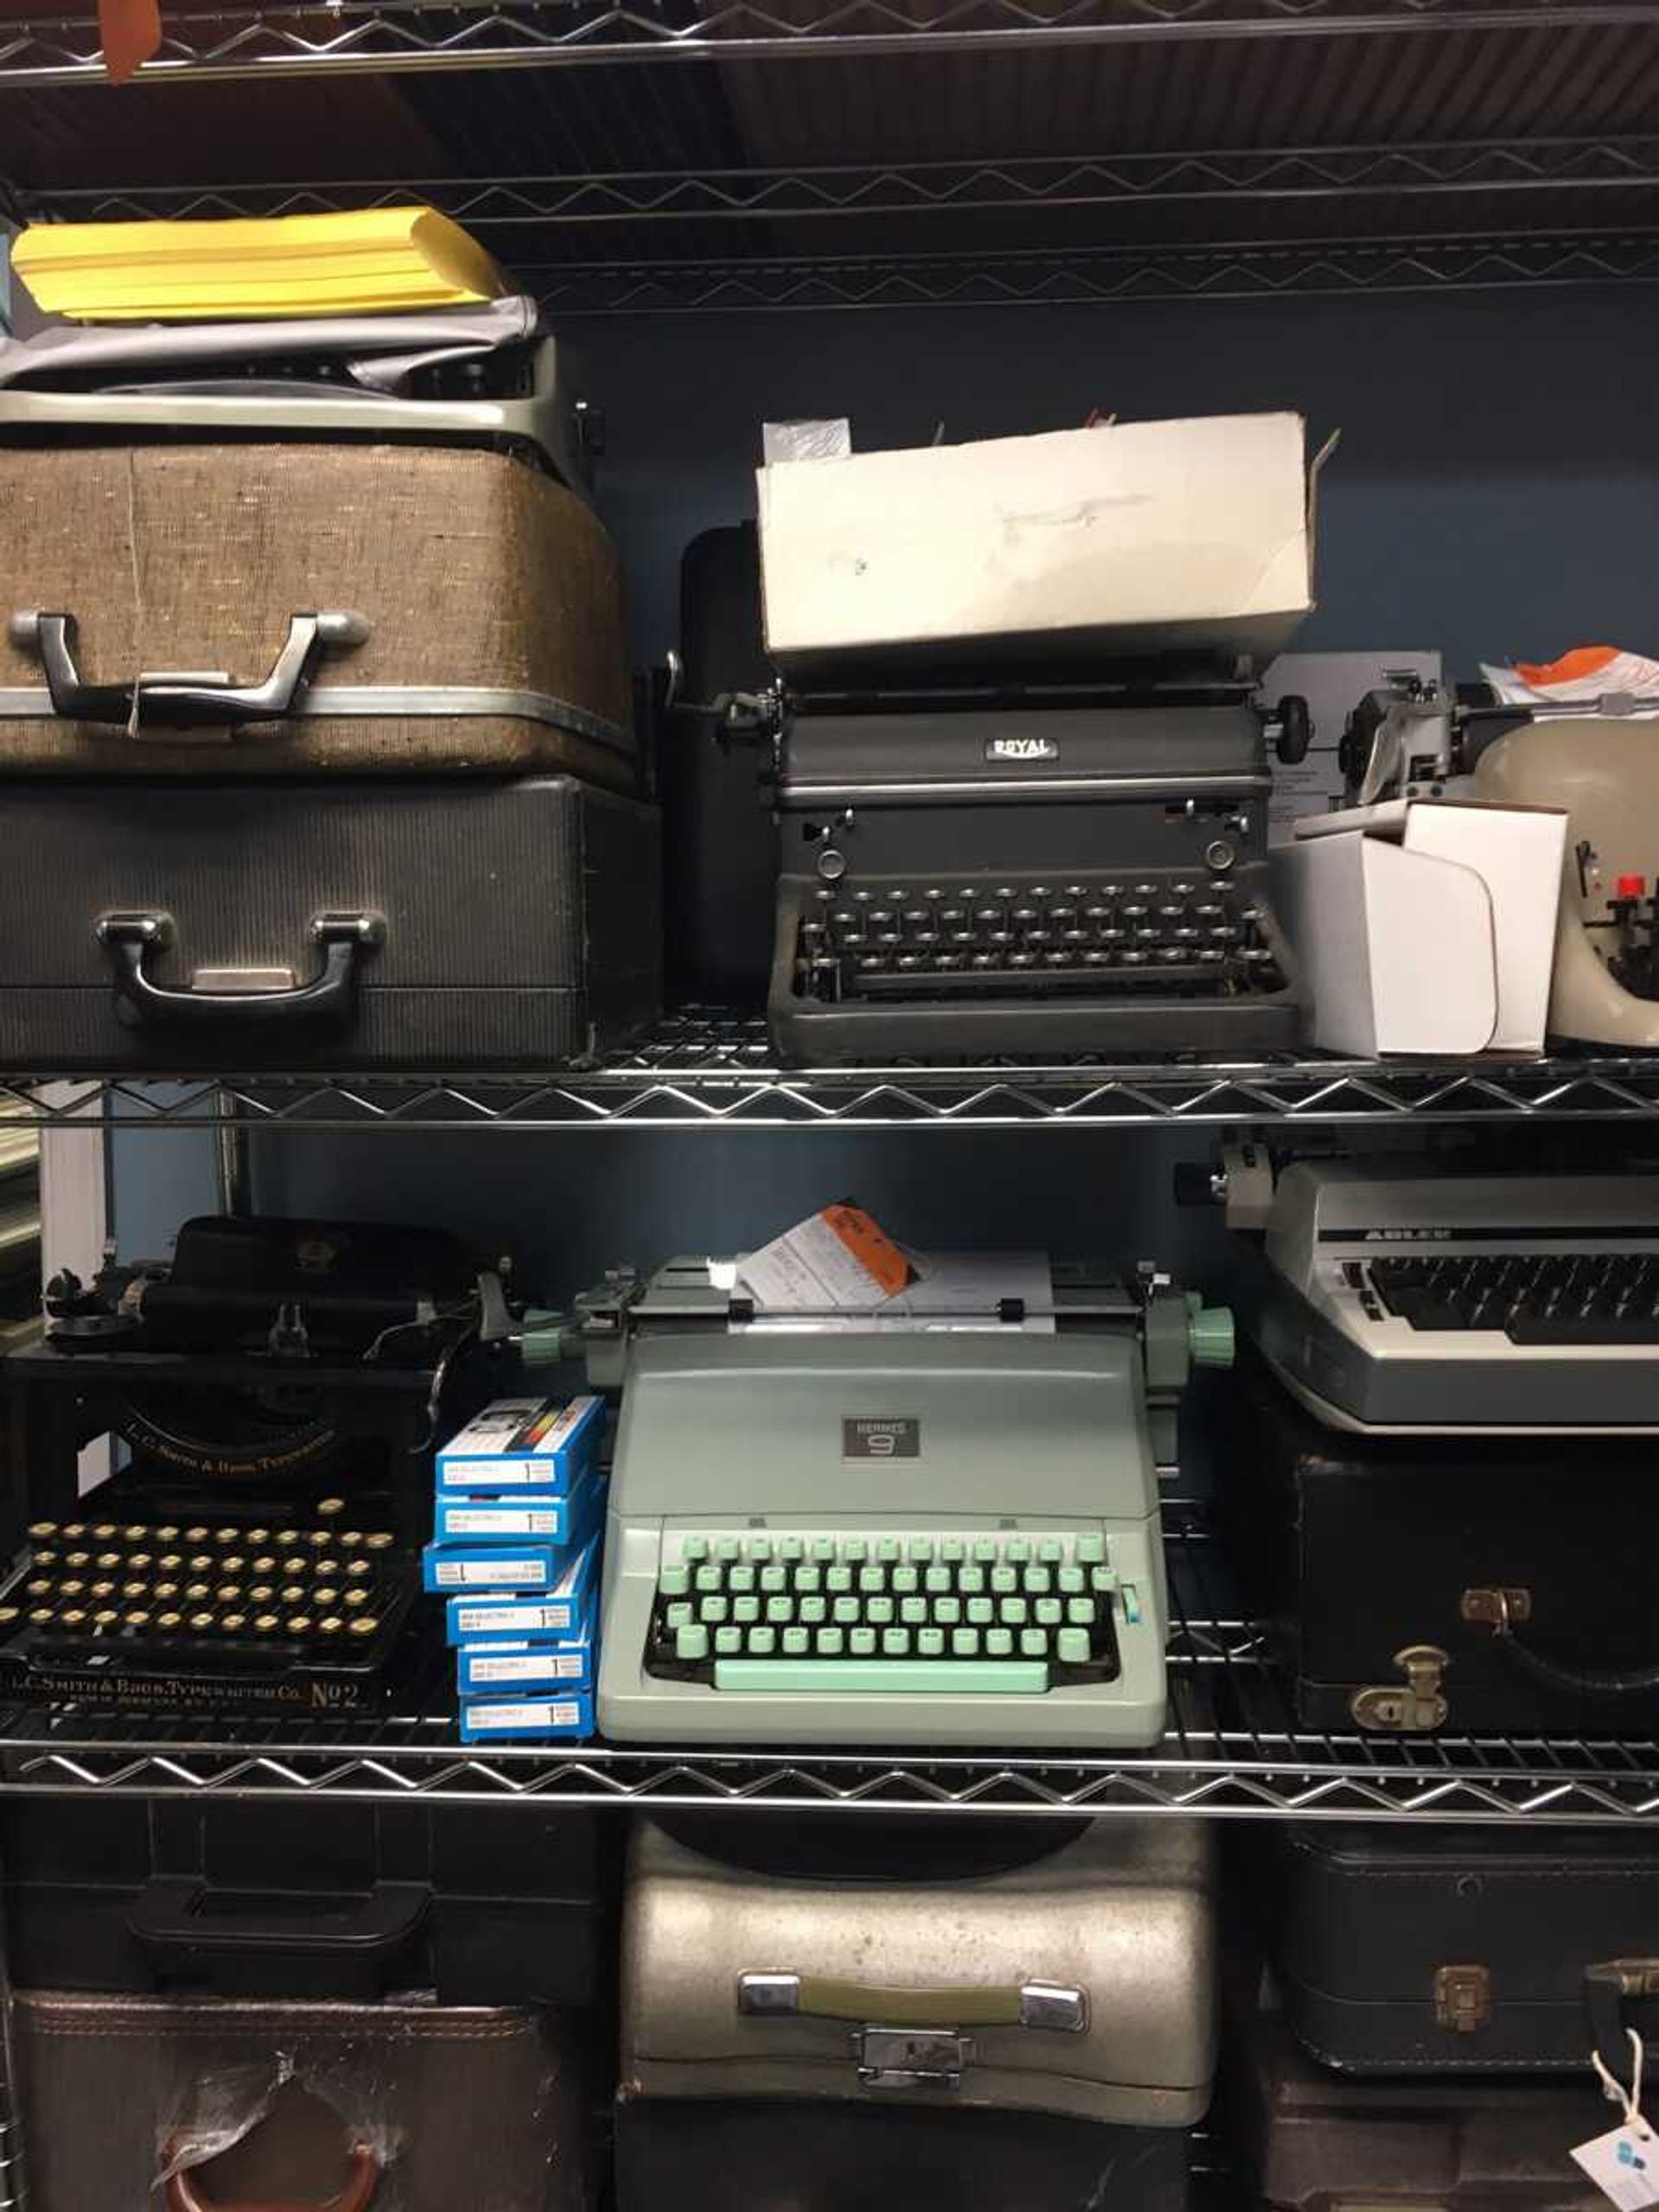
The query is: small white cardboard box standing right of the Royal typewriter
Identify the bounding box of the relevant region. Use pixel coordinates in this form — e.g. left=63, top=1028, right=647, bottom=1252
left=1272, top=801, right=1566, bottom=1059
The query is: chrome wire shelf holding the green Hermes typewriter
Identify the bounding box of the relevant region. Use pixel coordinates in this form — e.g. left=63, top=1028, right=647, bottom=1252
left=0, top=1504, right=1659, bottom=1827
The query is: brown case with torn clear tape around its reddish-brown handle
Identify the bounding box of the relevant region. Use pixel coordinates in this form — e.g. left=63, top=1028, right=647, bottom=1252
left=13, top=1991, right=586, bottom=2212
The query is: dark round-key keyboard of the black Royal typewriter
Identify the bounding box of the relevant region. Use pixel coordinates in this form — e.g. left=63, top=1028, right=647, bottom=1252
left=794, top=872, right=1285, bottom=1004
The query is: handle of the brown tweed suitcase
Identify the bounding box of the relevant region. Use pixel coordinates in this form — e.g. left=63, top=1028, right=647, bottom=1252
left=9, top=608, right=370, bottom=736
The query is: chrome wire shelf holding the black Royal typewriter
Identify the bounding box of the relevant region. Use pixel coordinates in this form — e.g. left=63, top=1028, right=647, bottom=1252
left=16, top=1011, right=1659, bottom=1135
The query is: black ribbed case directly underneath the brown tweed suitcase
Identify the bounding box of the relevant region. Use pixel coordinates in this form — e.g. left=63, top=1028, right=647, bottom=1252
left=0, top=777, right=661, bottom=1075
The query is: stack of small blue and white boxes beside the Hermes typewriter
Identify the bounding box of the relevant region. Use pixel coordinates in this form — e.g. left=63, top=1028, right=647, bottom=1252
left=423, top=1398, right=604, bottom=1743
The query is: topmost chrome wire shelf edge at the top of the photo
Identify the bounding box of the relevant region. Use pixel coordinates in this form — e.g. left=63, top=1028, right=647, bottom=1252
left=0, top=0, right=1659, bottom=86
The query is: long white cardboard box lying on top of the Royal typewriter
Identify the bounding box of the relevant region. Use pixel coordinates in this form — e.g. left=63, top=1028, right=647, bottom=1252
left=759, top=414, right=1325, bottom=672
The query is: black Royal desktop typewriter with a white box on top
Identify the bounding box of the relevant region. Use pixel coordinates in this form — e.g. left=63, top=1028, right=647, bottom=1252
left=752, top=668, right=1310, bottom=1062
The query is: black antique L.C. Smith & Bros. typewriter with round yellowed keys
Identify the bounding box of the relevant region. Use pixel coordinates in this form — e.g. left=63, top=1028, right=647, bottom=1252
left=0, top=1219, right=506, bottom=1712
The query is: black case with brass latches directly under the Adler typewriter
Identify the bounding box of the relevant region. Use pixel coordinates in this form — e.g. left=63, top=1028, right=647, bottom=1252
left=1219, top=1358, right=1659, bottom=1737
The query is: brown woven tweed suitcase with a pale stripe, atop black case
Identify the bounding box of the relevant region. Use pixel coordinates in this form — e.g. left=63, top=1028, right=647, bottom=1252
left=0, top=434, right=637, bottom=790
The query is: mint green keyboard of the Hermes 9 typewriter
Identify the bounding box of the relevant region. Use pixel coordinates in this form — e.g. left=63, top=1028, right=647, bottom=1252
left=646, top=1529, right=1141, bottom=1697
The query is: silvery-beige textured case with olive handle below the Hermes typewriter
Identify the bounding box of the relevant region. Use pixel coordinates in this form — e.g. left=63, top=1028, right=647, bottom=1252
left=621, top=1818, right=1217, bottom=2128
